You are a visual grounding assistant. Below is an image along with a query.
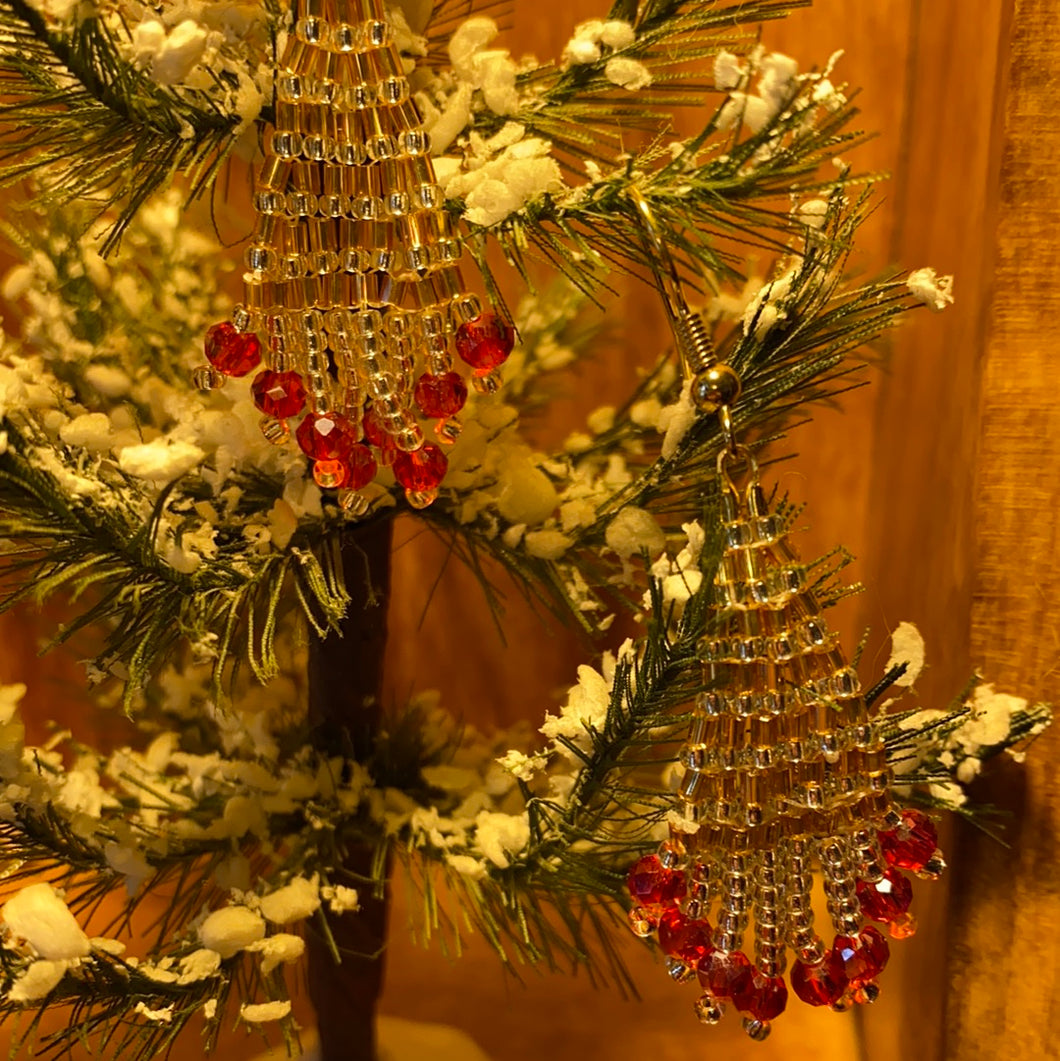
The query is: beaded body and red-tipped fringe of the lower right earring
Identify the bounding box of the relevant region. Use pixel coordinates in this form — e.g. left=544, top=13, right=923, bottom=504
left=629, top=474, right=942, bottom=1039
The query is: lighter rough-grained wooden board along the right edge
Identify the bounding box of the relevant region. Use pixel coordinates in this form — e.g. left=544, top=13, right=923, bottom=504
left=944, top=0, right=1060, bottom=1061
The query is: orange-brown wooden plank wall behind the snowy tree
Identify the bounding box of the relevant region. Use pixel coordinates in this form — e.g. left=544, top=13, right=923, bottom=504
left=2, top=0, right=1060, bottom=1061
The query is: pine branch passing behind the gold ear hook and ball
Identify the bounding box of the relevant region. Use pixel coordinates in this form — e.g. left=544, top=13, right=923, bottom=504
left=423, top=190, right=914, bottom=630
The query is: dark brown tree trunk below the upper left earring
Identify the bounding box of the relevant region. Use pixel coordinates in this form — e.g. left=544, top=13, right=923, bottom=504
left=307, top=520, right=392, bottom=1061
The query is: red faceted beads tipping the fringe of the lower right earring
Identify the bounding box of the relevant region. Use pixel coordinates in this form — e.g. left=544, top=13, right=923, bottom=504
left=627, top=808, right=942, bottom=1039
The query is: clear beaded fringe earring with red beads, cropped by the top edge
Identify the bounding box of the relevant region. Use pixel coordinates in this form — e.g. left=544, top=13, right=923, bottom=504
left=197, top=0, right=514, bottom=511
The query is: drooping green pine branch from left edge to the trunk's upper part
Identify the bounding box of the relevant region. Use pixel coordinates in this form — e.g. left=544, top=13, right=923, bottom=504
left=0, top=425, right=347, bottom=707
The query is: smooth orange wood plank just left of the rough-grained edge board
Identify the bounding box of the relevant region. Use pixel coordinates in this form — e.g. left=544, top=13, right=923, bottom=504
left=862, top=0, right=1006, bottom=1061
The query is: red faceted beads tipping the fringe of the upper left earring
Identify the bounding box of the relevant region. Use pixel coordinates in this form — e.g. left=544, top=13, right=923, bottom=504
left=196, top=312, right=515, bottom=506
